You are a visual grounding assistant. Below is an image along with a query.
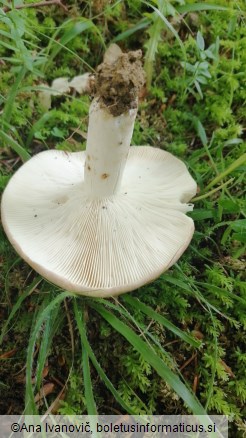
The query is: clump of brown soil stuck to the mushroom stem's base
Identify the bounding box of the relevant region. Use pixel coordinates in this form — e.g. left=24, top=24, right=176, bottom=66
left=95, top=44, right=145, bottom=117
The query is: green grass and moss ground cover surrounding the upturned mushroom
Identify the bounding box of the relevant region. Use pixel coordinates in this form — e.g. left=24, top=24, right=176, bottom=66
left=0, top=0, right=246, bottom=434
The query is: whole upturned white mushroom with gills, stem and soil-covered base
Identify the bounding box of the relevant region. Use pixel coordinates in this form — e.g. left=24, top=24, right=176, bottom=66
left=1, top=45, right=196, bottom=297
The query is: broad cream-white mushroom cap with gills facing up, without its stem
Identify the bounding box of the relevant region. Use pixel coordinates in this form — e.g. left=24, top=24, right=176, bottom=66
left=2, top=146, right=196, bottom=297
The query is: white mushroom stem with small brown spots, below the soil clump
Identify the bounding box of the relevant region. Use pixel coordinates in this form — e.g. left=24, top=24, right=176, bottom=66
left=84, top=98, right=137, bottom=198
